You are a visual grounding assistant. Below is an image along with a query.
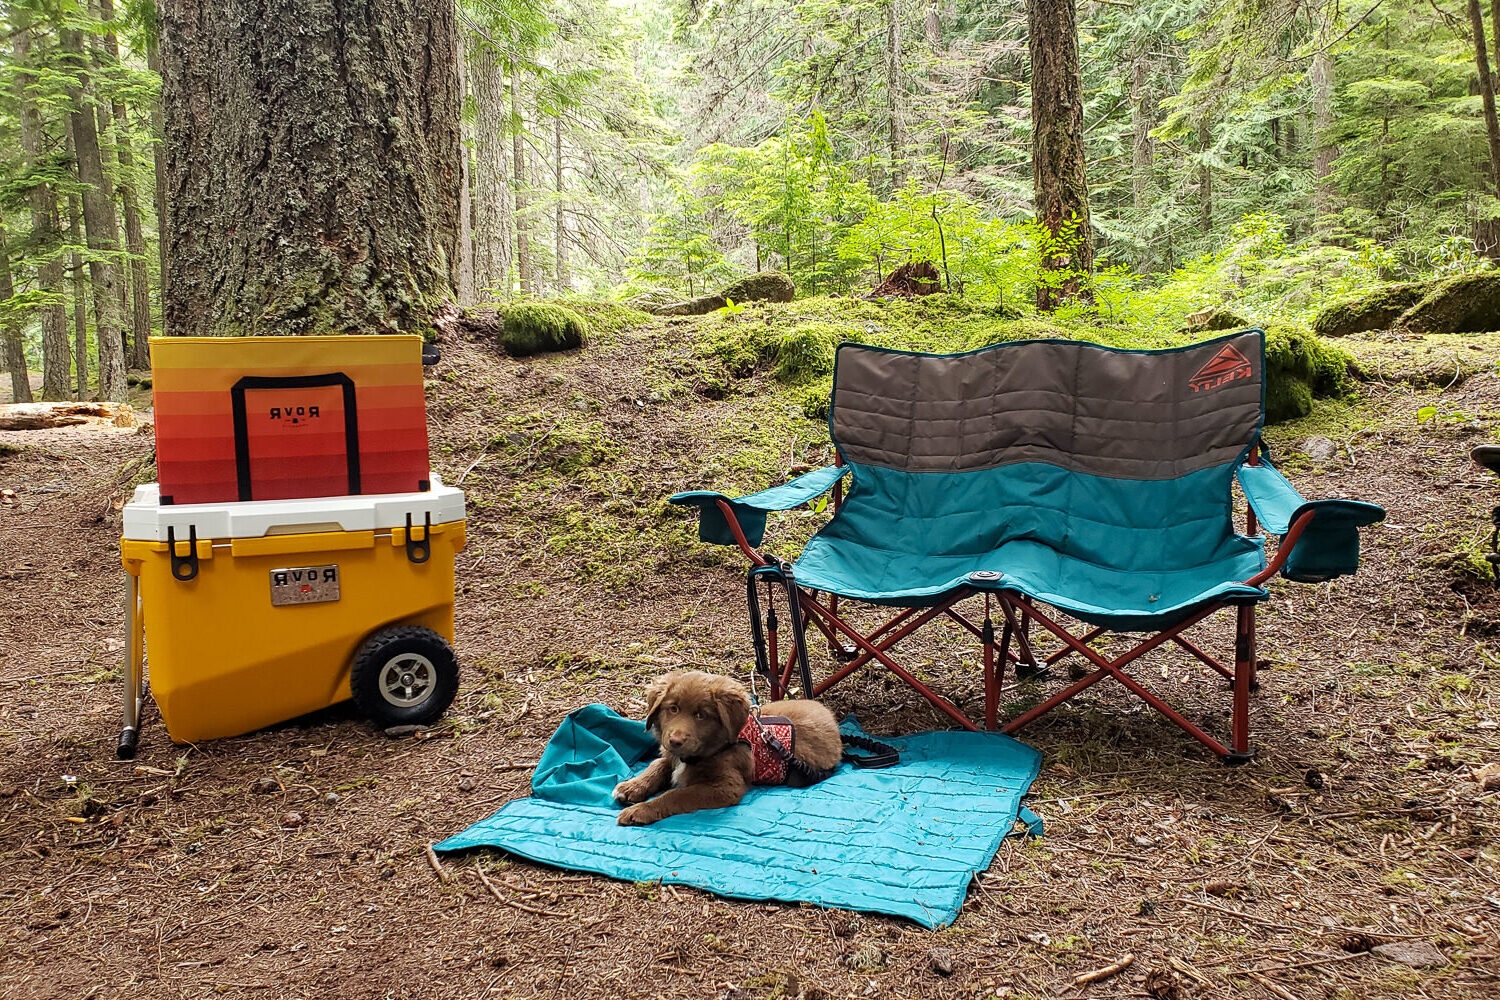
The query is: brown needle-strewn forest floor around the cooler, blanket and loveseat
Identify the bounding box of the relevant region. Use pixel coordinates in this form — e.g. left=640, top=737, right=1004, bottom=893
left=0, top=305, right=1500, bottom=1000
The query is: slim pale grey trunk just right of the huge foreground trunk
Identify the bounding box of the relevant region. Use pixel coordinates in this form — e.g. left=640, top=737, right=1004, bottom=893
left=468, top=40, right=512, bottom=298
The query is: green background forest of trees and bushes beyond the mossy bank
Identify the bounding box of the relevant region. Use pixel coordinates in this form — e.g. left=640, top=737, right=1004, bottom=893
left=0, top=0, right=1500, bottom=399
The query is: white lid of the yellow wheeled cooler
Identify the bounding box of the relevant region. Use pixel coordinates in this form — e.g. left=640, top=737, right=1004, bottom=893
left=123, top=474, right=464, bottom=541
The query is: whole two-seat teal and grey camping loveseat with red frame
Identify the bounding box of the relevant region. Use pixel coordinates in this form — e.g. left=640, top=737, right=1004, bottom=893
left=672, top=330, right=1385, bottom=763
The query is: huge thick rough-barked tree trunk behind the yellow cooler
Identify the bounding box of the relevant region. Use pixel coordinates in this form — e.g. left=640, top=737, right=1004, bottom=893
left=162, top=0, right=459, bottom=336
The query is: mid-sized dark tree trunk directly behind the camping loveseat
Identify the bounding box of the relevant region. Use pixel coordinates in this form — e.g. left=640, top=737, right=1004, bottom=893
left=1026, top=0, right=1094, bottom=310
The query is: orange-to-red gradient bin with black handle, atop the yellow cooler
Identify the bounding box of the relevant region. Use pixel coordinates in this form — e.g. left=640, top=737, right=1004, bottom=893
left=152, top=336, right=431, bottom=505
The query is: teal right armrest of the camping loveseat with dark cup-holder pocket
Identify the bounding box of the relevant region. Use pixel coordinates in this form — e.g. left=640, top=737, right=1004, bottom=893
left=1238, top=459, right=1386, bottom=583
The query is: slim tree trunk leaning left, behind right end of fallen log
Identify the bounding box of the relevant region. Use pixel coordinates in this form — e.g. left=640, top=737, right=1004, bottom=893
left=59, top=28, right=129, bottom=403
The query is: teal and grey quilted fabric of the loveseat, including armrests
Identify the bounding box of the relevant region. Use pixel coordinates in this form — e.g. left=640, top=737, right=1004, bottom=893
left=672, top=330, right=1385, bottom=631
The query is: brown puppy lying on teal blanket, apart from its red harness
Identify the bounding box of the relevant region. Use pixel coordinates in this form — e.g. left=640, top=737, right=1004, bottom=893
left=615, top=670, right=843, bottom=826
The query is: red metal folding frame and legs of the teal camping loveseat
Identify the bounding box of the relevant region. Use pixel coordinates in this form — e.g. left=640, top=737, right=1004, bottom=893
left=717, top=453, right=1314, bottom=763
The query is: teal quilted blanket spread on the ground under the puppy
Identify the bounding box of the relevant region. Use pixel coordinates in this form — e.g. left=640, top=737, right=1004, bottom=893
left=437, top=705, right=1041, bottom=927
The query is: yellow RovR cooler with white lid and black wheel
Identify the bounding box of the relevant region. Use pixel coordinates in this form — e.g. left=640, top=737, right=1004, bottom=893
left=119, top=475, right=464, bottom=757
